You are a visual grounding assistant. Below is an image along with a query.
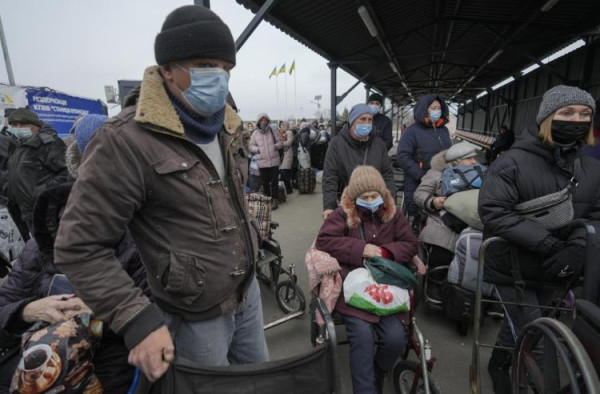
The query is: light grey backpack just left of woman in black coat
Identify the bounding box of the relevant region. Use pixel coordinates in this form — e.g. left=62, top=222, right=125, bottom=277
left=448, top=227, right=492, bottom=296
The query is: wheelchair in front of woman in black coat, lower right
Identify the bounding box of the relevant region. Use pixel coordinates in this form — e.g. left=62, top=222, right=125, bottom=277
left=469, top=237, right=600, bottom=393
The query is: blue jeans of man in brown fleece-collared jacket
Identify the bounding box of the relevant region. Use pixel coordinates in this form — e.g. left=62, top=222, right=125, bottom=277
left=165, top=277, right=269, bottom=366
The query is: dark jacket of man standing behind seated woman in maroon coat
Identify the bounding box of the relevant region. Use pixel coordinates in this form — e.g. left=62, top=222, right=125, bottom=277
left=323, top=127, right=396, bottom=210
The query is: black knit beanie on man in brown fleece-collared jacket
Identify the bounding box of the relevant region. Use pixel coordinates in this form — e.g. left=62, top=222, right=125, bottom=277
left=154, top=5, right=236, bottom=65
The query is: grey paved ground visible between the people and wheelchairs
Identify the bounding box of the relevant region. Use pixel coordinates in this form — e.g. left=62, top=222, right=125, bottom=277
left=262, top=184, right=499, bottom=394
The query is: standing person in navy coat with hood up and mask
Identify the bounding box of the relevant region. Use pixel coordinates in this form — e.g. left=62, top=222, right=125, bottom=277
left=397, top=94, right=452, bottom=215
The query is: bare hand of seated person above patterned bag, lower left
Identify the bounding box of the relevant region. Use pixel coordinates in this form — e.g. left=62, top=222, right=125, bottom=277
left=22, top=294, right=91, bottom=324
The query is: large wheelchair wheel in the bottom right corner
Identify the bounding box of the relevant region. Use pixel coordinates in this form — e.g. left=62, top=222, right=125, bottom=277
left=512, top=317, right=600, bottom=394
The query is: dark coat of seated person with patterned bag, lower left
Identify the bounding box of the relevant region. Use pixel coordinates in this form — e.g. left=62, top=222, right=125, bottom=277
left=0, top=184, right=150, bottom=393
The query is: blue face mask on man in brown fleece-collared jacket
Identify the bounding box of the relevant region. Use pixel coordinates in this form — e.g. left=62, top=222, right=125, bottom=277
left=178, top=64, right=229, bottom=117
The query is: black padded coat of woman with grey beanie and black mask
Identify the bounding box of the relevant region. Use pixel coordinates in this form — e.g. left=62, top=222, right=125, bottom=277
left=479, top=127, right=600, bottom=284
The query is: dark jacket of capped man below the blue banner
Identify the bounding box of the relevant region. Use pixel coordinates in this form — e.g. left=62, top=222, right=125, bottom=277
left=7, top=125, right=68, bottom=223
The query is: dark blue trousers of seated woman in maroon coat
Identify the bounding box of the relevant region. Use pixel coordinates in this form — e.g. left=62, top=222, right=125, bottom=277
left=343, top=316, right=406, bottom=394
